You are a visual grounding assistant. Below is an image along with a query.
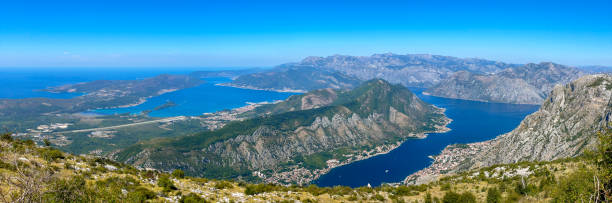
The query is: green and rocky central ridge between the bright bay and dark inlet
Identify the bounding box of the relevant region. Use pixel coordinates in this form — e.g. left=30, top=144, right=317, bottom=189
left=114, top=80, right=449, bottom=183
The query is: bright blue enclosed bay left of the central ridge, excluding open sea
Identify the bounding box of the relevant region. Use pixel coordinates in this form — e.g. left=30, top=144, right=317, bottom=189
left=92, top=78, right=295, bottom=117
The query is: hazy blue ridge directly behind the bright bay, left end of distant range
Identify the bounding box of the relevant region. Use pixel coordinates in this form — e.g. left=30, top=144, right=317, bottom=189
left=224, top=65, right=361, bottom=92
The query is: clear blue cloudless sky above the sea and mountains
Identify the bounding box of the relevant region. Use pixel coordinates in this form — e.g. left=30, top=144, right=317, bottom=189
left=0, top=0, right=612, bottom=67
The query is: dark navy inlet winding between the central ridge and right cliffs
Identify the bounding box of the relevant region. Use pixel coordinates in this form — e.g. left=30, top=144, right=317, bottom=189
left=314, top=89, right=539, bottom=187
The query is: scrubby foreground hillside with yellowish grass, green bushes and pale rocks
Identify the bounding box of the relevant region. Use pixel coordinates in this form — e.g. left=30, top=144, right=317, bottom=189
left=0, top=131, right=609, bottom=203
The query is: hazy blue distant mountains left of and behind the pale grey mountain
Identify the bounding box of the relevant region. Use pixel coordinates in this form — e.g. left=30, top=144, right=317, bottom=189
left=230, top=53, right=518, bottom=90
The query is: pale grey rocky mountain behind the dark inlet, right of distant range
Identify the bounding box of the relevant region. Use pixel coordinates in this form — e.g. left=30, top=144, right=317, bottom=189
left=426, top=63, right=583, bottom=104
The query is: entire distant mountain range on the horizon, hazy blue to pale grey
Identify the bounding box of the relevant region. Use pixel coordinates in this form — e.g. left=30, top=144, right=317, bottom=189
left=226, top=53, right=584, bottom=104
